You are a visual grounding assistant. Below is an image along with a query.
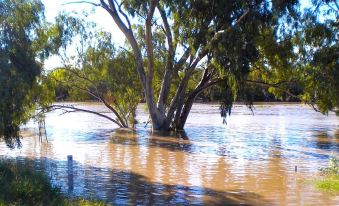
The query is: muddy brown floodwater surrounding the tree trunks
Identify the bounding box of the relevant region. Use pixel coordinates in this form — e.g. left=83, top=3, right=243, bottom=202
left=0, top=103, right=339, bottom=205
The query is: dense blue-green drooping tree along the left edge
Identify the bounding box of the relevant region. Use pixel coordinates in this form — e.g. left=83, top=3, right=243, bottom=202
left=0, top=0, right=57, bottom=147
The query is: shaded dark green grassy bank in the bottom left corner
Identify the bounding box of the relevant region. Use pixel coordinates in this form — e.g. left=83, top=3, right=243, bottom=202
left=0, top=160, right=105, bottom=206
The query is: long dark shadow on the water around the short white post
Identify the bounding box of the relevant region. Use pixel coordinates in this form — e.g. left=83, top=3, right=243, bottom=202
left=1, top=157, right=272, bottom=205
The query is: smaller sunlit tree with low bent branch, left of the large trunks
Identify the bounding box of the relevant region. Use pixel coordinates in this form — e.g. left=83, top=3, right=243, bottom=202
left=47, top=13, right=142, bottom=128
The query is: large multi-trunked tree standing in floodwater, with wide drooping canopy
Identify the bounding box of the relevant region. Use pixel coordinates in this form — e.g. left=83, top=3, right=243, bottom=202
left=79, top=0, right=338, bottom=130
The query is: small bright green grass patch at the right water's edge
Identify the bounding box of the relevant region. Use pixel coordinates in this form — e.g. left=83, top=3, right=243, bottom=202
left=315, top=158, right=339, bottom=193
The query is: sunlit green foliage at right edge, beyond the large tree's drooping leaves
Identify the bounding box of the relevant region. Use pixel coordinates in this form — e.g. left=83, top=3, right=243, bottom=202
left=244, top=1, right=339, bottom=114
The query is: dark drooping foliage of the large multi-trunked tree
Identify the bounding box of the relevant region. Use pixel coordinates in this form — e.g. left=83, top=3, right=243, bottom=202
left=119, top=0, right=298, bottom=114
